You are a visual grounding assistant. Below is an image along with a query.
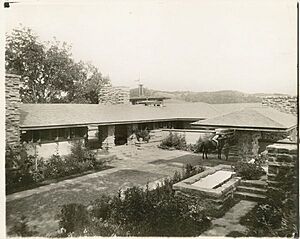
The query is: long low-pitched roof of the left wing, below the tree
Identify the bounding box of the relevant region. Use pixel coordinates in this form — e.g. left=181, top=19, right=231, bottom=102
left=20, top=102, right=219, bottom=128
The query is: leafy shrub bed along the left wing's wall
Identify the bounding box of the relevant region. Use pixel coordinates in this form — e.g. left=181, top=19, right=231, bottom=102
left=5, top=142, right=106, bottom=193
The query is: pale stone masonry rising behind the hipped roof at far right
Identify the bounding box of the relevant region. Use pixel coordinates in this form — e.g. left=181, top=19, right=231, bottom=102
left=262, top=96, right=298, bottom=115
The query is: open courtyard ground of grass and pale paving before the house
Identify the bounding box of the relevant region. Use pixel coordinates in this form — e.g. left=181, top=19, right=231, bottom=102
left=6, top=144, right=230, bottom=236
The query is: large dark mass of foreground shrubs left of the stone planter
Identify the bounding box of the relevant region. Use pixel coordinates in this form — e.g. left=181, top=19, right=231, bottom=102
left=56, top=165, right=210, bottom=236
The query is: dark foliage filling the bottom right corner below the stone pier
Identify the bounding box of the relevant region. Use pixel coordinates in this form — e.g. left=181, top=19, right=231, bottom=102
left=241, top=168, right=298, bottom=237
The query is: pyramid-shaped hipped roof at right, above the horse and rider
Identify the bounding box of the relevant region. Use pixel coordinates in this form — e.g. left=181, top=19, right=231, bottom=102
left=192, top=107, right=297, bottom=130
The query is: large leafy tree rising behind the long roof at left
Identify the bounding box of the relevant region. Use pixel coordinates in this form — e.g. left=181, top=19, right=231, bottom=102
left=5, top=28, right=109, bottom=103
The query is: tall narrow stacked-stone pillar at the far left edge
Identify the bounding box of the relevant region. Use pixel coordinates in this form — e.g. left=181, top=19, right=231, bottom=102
left=5, top=74, right=21, bottom=147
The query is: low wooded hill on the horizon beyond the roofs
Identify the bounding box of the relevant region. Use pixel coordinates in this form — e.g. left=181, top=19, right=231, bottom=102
left=130, top=88, right=290, bottom=104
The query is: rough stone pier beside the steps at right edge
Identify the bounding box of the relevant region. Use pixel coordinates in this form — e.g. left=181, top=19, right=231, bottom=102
left=267, top=142, right=299, bottom=187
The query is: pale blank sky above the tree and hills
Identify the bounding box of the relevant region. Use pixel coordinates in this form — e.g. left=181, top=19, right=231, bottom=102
left=4, top=0, right=297, bottom=94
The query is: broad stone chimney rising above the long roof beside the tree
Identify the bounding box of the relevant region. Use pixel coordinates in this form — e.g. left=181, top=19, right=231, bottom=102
left=99, top=84, right=129, bottom=104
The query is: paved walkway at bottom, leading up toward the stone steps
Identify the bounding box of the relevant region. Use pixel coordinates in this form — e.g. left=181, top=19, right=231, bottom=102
left=201, top=200, right=257, bottom=237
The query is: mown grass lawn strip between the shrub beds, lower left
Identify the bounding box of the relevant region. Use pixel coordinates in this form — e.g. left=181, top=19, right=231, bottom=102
left=6, top=170, right=166, bottom=236
